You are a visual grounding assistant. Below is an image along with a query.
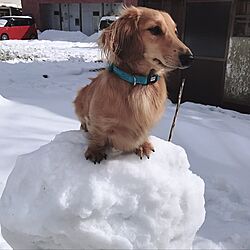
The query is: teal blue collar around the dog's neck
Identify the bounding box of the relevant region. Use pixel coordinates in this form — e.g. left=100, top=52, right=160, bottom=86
left=108, top=64, right=160, bottom=85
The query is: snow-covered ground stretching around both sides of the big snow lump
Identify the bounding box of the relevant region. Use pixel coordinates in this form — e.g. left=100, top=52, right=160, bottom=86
left=0, top=30, right=250, bottom=249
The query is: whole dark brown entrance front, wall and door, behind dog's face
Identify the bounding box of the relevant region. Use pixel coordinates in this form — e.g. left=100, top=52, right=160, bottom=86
left=139, top=0, right=234, bottom=106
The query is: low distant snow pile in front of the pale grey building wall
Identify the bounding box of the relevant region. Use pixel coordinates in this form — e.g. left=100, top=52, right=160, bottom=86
left=38, top=30, right=88, bottom=42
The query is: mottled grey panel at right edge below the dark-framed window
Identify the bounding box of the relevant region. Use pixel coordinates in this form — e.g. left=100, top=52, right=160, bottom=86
left=224, top=37, right=250, bottom=106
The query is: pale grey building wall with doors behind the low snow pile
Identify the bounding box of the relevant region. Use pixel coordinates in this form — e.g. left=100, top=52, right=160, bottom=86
left=39, top=3, right=122, bottom=35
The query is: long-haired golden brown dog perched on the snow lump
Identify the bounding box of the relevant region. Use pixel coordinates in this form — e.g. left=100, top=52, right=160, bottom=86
left=74, top=7, right=192, bottom=163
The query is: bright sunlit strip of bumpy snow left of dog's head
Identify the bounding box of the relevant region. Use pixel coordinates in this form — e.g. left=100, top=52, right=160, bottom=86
left=0, top=40, right=100, bottom=63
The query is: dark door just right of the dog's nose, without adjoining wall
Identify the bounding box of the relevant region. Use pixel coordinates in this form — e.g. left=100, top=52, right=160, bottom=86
left=183, top=0, right=232, bottom=106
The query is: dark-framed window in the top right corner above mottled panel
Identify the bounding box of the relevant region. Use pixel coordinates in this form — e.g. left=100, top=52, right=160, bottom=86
left=233, top=0, right=250, bottom=37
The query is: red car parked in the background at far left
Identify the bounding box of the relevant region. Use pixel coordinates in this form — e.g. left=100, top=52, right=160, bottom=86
left=0, top=16, right=37, bottom=40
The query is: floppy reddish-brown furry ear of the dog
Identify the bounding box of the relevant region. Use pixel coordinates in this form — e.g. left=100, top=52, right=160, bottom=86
left=99, top=7, right=143, bottom=62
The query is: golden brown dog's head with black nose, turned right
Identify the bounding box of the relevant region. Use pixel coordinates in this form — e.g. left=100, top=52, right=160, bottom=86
left=99, top=7, right=193, bottom=71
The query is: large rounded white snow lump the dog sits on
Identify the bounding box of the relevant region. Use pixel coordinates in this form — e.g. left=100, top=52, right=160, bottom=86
left=0, top=131, right=205, bottom=249
